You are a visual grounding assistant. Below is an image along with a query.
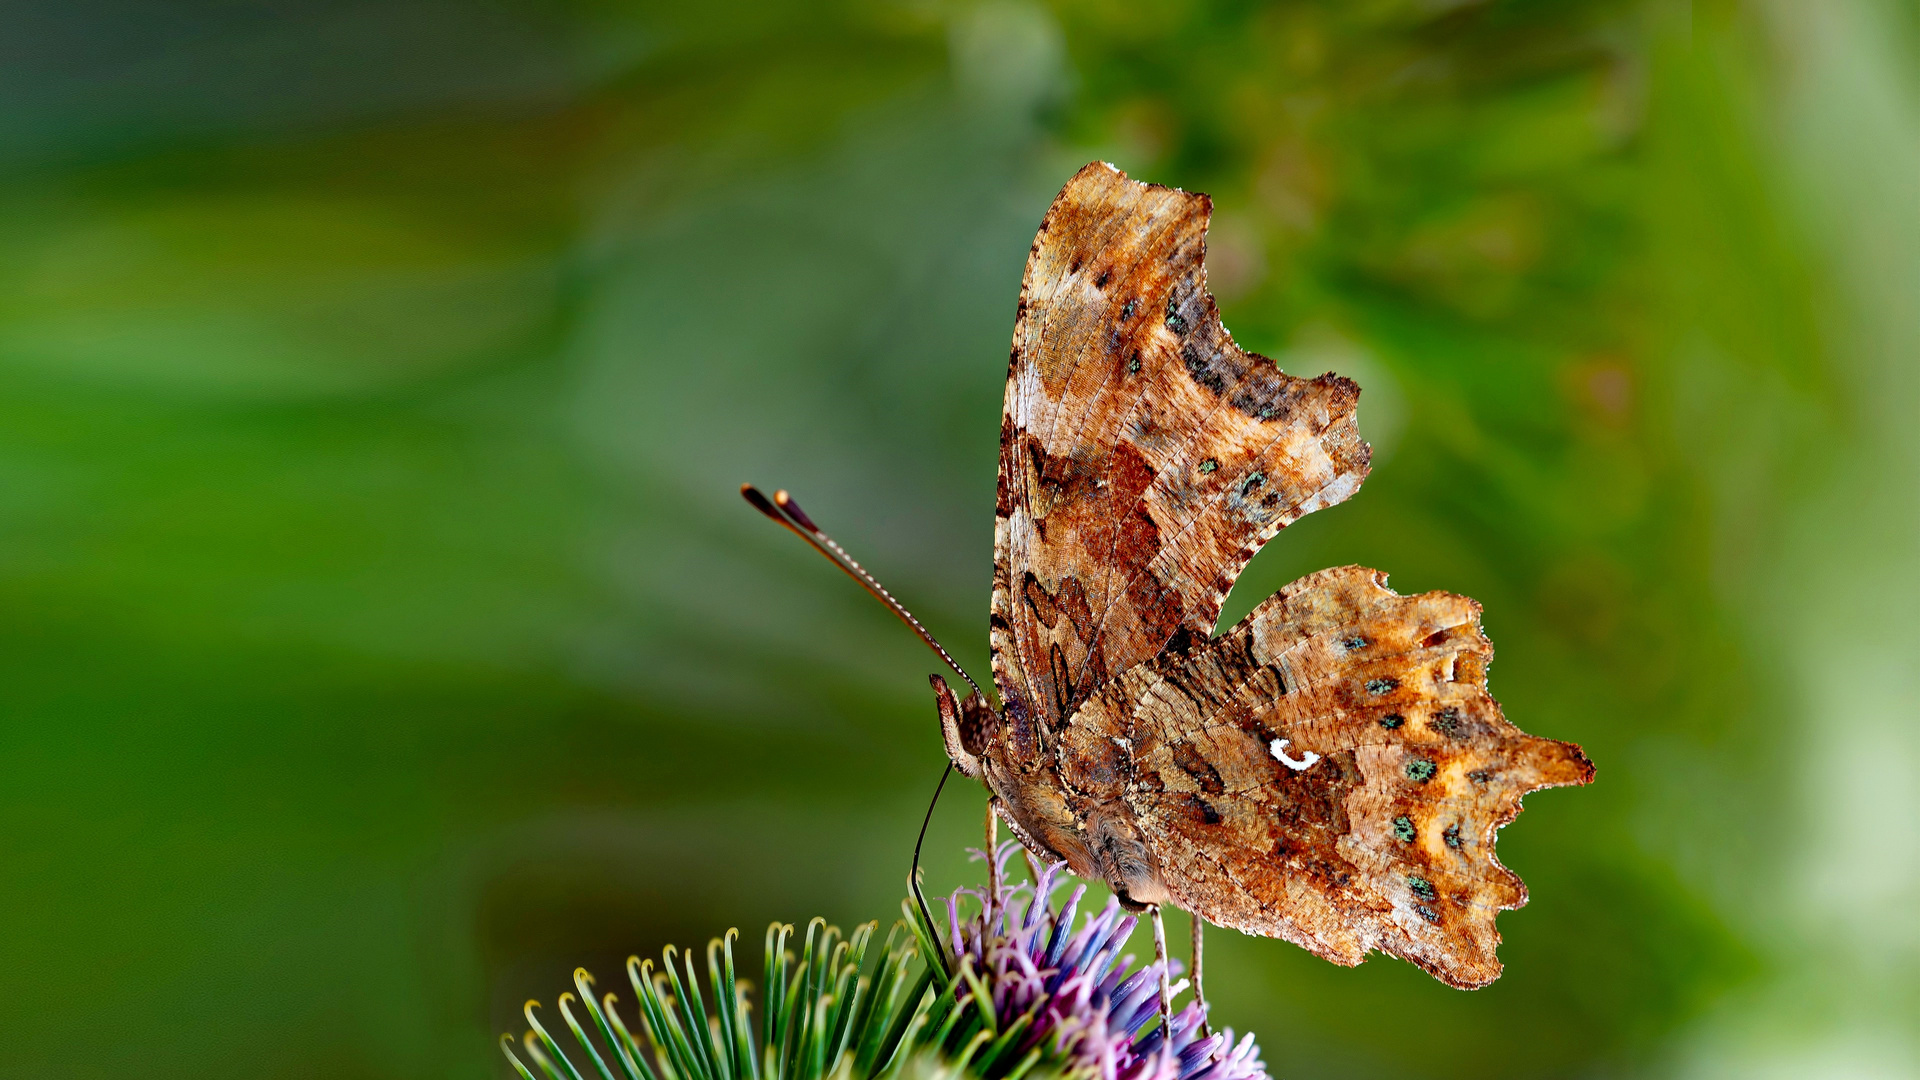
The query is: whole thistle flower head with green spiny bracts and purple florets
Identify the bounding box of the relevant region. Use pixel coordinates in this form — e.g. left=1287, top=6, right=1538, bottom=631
left=501, top=844, right=1267, bottom=1080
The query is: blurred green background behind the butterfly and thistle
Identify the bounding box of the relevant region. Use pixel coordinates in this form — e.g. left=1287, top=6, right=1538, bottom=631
left=0, top=0, right=1920, bottom=1080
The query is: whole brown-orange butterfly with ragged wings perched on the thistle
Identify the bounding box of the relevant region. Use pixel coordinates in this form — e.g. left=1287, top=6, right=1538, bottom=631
left=743, top=161, right=1594, bottom=988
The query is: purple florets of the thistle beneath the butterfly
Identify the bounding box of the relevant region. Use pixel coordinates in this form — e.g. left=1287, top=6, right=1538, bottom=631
left=947, top=842, right=1269, bottom=1080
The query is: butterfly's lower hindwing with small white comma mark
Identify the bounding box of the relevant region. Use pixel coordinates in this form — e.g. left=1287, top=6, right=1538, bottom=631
left=1127, top=567, right=1594, bottom=986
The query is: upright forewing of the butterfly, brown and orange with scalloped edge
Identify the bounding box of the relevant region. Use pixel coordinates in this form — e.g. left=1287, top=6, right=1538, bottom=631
left=993, top=163, right=1367, bottom=737
